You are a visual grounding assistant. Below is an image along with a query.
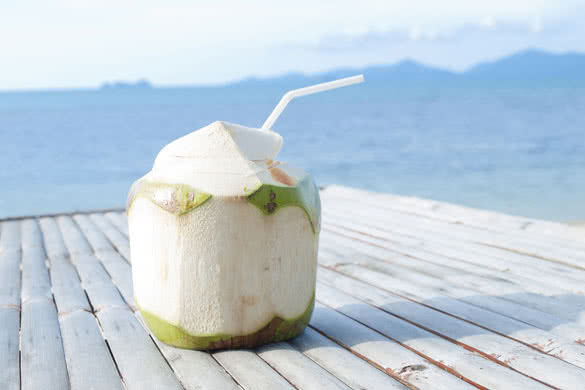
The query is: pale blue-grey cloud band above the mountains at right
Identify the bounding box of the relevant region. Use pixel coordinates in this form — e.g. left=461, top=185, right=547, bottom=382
left=278, top=17, right=585, bottom=70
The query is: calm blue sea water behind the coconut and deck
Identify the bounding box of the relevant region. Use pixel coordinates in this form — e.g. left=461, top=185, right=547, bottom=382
left=0, top=84, right=585, bottom=221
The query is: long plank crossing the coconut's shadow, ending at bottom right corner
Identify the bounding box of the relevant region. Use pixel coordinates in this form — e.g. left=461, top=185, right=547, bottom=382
left=320, top=270, right=585, bottom=389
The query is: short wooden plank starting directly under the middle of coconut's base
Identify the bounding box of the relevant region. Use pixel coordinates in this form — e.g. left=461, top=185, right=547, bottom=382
left=213, top=349, right=294, bottom=390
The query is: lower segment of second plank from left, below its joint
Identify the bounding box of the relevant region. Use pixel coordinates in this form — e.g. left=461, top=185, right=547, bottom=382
left=20, top=299, right=70, bottom=390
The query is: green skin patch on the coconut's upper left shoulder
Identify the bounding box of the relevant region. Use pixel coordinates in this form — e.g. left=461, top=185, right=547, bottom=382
left=126, top=179, right=211, bottom=216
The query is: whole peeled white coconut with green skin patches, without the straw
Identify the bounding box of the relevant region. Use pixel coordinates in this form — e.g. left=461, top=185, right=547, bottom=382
left=127, top=122, right=320, bottom=350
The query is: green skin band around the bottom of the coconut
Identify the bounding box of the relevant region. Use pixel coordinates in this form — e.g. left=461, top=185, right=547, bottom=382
left=138, top=292, right=315, bottom=351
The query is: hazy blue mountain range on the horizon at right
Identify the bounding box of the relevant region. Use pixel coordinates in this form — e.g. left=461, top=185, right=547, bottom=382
left=230, top=50, right=585, bottom=86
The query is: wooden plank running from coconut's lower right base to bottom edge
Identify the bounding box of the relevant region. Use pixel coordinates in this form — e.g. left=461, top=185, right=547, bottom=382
left=286, top=328, right=407, bottom=389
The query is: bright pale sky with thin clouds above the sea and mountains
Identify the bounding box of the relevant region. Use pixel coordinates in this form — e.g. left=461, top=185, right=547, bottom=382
left=0, top=0, right=585, bottom=90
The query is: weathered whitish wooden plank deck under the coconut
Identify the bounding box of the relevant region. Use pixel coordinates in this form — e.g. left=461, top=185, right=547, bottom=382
left=0, top=186, right=585, bottom=390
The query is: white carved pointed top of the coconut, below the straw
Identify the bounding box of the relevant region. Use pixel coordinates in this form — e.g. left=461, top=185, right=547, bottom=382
left=144, top=121, right=305, bottom=196
